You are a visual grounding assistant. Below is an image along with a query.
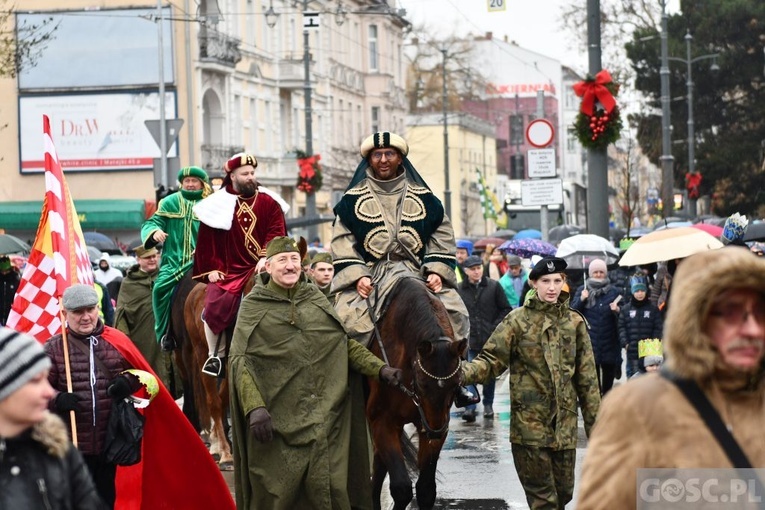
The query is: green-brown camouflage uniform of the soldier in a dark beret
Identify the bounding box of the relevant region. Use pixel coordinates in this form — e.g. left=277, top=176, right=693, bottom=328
left=462, top=291, right=600, bottom=509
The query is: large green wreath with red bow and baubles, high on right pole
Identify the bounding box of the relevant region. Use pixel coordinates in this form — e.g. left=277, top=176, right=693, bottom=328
left=573, top=69, right=622, bottom=150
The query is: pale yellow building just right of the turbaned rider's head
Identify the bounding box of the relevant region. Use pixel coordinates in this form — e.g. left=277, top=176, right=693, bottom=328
left=407, top=112, right=497, bottom=238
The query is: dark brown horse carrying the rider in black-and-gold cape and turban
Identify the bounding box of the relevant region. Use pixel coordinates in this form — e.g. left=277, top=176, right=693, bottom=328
left=366, top=278, right=467, bottom=510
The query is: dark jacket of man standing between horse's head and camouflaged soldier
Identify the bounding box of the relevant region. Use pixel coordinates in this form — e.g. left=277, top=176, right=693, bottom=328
left=457, top=276, right=512, bottom=351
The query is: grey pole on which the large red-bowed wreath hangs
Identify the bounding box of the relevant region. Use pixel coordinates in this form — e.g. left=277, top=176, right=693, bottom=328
left=587, top=0, right=608, bottom=239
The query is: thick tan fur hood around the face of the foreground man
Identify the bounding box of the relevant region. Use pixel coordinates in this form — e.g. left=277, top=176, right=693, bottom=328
left=663, top=247, right=765, bottom=382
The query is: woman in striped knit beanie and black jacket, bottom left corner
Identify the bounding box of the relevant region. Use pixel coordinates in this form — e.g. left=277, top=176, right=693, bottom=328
left=0, top=328, right=106, bottom=510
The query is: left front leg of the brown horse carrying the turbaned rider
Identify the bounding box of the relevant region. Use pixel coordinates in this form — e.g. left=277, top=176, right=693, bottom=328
left=372, top=422, right=414, bottom=510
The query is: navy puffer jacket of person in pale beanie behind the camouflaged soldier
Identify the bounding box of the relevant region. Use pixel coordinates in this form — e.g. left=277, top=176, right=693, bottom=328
left=571, top=285, right=624, bottom=365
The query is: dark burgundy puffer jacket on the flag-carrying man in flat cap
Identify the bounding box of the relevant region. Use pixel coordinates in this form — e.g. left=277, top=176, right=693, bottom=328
left=44, top=320, right=132, bottom=455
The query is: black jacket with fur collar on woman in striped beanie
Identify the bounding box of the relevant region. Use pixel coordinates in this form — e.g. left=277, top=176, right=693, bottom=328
left=0, top=414, right=106, bottom=510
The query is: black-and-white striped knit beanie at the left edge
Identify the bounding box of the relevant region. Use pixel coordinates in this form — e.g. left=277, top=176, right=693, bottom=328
left=0, top=327, right=51, bottom=401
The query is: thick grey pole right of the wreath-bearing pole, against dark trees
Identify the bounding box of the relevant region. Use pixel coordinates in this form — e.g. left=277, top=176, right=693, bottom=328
left=659, top=0, right=675, bottom=218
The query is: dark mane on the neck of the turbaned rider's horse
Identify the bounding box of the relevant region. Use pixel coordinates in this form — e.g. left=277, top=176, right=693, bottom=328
left=391, top=278, right=450, bottom=342
